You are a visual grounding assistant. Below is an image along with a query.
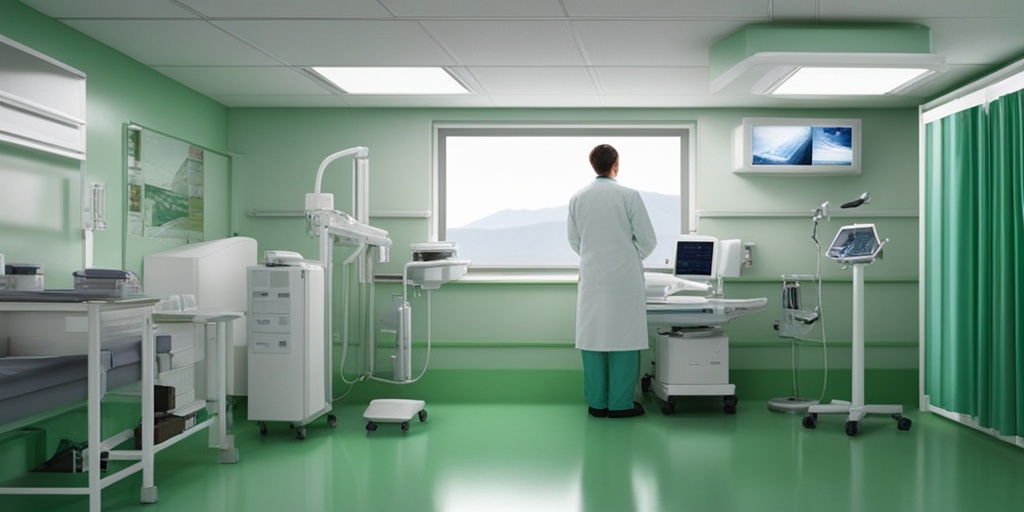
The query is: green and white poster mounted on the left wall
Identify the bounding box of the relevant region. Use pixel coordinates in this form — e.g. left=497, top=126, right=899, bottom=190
left=126, top=125, right=204, bottom=242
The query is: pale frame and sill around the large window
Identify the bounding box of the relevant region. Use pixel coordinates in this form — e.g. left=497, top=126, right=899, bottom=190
left=430, top=122, right=696, bottom=282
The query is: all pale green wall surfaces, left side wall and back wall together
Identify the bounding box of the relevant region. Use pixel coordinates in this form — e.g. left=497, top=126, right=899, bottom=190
left=0, top=0, right=918, bottom=407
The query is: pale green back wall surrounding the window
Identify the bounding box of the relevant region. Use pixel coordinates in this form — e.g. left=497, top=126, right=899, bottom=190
left=228, top=109, right=919, bottom=403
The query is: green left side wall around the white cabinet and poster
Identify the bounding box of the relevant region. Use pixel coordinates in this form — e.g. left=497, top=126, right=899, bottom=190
left=0, top=0, right=229, bottom=288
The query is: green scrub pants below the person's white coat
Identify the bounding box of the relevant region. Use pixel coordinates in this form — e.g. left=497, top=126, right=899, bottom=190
left=581, top=350, right=640, bottom=411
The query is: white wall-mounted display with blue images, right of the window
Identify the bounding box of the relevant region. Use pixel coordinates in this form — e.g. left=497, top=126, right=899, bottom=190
left=733, top=118, right=860, bottom=176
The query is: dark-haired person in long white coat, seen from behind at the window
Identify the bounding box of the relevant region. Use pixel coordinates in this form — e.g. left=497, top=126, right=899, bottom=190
left=567, top=144, right=657, bottom=418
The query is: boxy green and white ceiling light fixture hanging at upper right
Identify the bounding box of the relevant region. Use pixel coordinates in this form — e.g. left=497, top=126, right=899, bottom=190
left=711, top=25, right=946, bottom=96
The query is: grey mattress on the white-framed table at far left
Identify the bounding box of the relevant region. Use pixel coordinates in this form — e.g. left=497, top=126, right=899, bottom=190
left=0, top=335, right=171, bottom=425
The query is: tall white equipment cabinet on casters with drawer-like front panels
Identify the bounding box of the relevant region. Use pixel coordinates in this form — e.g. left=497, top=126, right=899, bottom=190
left=249, top=264, right=337, bottom=439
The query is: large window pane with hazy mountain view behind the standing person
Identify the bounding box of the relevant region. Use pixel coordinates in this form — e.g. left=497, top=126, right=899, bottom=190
left=437, top=126, right=691, bottom=268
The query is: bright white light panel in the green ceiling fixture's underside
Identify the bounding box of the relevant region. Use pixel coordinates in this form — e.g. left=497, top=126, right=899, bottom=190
left=768, top=68, right=932, bottom=95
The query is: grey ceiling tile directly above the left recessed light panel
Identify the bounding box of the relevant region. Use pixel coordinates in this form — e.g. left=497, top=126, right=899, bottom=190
left=214, top=19, right=455, bottom=66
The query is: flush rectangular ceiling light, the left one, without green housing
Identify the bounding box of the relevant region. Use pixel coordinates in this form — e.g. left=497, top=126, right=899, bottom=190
left=310, top=67, right=469, bottom=94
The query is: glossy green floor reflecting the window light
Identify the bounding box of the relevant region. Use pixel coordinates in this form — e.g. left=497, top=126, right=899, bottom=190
left=0, top=398, right=1024, bottom=512
